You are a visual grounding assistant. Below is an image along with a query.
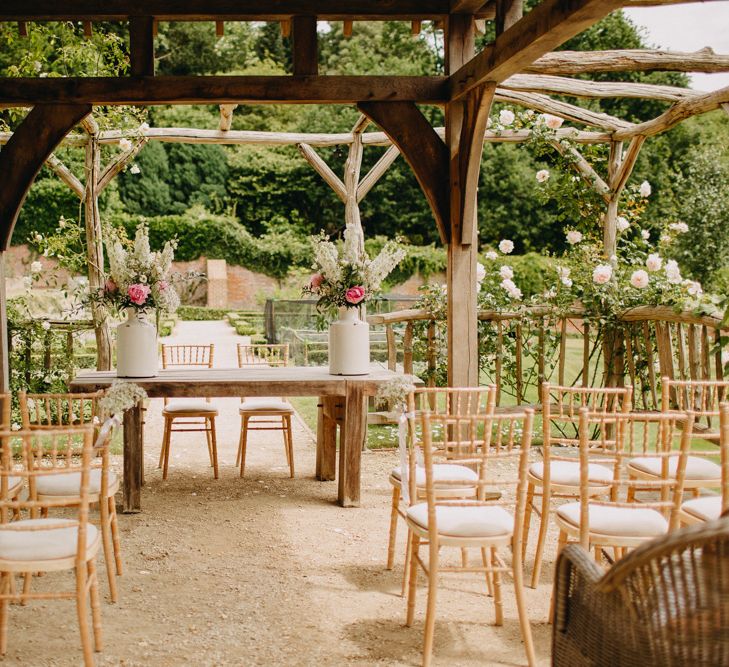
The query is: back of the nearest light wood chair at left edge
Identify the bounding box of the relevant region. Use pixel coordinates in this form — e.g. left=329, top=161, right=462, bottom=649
left=0, top=426, right=94, bottom=559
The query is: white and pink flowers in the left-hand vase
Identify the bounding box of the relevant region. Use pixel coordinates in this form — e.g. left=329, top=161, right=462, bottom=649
left=92, top=224, right=180, bottom=313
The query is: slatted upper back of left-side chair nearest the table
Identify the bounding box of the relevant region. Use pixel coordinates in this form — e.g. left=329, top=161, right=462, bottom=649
left=18, top=391, right=104, bottom=431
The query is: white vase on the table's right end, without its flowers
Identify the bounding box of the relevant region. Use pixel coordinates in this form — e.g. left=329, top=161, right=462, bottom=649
left=329, top=308, right=370, bottom=375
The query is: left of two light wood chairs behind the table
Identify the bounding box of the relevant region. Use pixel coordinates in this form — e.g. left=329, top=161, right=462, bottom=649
left=158, top=343, right=218, bottom=479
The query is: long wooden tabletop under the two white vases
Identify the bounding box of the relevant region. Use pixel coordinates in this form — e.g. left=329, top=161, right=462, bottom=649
left=70, top=365, right=410, bottom=398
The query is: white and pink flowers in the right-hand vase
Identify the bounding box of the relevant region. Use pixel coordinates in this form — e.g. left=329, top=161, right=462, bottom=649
left=303, top=228, right=405, bottom=312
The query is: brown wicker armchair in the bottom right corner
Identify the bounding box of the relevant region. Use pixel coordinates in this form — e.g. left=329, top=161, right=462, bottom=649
left=552, top=519, right=729, bottom=667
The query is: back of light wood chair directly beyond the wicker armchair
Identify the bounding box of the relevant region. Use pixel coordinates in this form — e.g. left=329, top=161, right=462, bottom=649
left=579, top=408, right=694, bottom=549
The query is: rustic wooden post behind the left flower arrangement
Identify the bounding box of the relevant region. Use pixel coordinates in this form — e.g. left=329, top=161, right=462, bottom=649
left=84, top=121, right=111, bottom=371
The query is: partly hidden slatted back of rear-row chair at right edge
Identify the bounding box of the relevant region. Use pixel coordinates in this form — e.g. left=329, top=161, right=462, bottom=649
left=661, top=377, right=729, bottom=442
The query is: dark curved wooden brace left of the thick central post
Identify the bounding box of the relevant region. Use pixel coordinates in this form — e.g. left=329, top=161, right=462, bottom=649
left=357, top=102, right=448, bottom=249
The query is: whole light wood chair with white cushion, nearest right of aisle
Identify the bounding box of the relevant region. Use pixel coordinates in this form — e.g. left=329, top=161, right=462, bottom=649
left=406, top=409, right=536, bottom=667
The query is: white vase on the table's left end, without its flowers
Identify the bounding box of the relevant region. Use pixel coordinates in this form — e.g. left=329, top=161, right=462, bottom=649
left=116, top=308, right=159, bottom=378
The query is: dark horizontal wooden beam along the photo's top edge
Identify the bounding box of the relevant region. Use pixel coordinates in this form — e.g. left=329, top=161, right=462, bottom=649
left=0, top=0, right=452, bottom=21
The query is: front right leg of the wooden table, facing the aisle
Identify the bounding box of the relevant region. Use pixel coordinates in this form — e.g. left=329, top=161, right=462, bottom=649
left=338, top=382, right=367, bottom=507
